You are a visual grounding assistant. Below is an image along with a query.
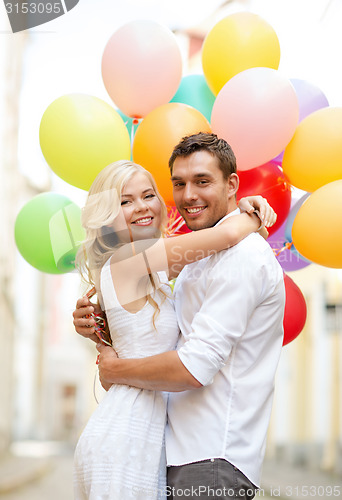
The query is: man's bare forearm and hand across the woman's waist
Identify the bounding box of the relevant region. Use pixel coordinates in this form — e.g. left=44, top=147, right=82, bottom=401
left=96, top=344, right=202, bottom=392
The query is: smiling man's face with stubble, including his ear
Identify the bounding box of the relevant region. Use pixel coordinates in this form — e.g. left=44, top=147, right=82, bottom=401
left=171, top=151, right=239, bottom=231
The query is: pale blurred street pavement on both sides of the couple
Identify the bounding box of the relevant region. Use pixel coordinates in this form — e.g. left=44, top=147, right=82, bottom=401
left=0, top=448, right=342, bottom=500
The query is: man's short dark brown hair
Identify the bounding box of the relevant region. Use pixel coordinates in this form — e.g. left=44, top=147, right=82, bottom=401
left=169, top=132, right=236, bottom=180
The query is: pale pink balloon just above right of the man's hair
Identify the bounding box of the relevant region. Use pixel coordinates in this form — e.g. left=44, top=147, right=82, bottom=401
left=211, top=68, right=299, bottom=171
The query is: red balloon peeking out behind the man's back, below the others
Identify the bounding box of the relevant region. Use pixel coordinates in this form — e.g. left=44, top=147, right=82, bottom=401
left=283, top=273, right=307, bottom=346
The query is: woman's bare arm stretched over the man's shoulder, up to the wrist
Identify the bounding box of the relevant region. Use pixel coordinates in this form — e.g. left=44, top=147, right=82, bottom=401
left=111, top=213, right=260, bottom=279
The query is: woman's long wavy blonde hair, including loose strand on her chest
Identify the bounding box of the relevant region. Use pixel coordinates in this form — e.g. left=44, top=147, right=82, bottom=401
left=76, top=160, right=167, bottom=324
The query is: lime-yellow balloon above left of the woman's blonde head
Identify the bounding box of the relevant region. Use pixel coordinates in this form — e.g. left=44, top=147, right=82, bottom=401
left=39, top=94, right=131, bottom=190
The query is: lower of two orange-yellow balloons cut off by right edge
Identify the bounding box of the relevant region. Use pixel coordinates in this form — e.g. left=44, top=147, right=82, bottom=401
left=292, top=180, right=342, bottom=268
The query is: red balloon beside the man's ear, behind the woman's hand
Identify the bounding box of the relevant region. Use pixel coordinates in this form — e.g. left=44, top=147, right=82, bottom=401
left=237, top=162, right=291, bottom=235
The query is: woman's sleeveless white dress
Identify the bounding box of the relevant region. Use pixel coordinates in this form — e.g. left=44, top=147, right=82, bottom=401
left=74, top=260, right=179, bottom=500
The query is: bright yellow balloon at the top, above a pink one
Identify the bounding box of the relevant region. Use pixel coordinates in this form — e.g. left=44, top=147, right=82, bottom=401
left=202, top=12, right=280, bottom=95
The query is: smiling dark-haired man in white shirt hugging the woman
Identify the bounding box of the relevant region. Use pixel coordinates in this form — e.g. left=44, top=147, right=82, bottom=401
left=74, top=133, right=285, bottom=499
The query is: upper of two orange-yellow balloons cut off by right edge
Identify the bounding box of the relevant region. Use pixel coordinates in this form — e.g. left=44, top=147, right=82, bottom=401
left=282, top=107, right=342, bottom=192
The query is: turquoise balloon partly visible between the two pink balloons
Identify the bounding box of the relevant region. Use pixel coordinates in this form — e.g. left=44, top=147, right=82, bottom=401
left=170, top=75, right=215, bottom=121
